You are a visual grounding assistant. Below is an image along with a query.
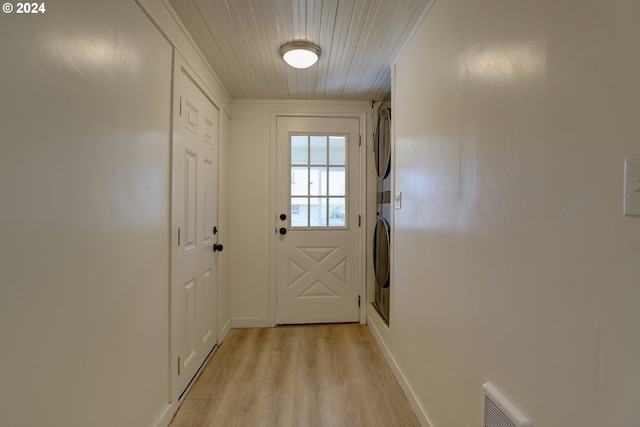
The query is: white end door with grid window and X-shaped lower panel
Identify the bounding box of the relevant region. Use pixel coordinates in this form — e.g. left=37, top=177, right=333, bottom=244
left=275, top=116, right=360, bottom=324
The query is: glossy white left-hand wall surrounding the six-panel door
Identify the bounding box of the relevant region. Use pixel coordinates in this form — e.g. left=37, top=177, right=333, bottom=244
left=0, top=0, right=229, bottom=427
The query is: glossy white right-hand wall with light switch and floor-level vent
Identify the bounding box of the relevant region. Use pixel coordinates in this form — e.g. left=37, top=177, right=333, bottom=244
left=374, top=0, right=640, bottom=427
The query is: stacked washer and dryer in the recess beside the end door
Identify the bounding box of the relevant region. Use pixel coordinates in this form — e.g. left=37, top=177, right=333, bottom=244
left=373, top=107, right=392, bottom=323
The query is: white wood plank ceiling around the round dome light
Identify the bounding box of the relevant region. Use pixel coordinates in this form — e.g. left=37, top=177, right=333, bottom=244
left=169, top=0, right=429, bottom=101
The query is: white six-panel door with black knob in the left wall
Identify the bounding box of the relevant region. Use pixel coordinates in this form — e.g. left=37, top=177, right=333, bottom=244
left=171, top=61, right=219, bottom=399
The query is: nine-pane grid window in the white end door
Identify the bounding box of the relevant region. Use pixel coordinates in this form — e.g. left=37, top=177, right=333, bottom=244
left=289, top=134, right=349, bottom=228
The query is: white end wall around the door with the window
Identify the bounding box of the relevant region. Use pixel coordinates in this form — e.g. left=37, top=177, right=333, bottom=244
left=225, top=100, right=370, bottom=327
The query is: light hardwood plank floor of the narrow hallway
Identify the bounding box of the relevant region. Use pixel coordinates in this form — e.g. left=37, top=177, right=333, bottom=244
left=170, top=324, right=420, bottom=427
